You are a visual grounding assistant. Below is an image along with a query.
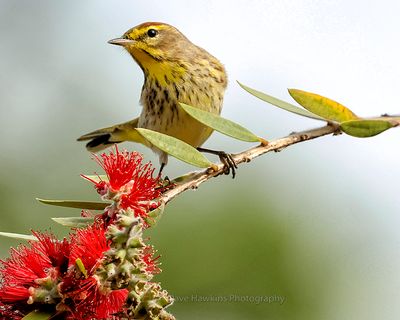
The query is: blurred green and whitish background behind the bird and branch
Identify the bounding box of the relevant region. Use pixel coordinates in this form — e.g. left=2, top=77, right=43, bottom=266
left=0, top=0, right=400, bottom=319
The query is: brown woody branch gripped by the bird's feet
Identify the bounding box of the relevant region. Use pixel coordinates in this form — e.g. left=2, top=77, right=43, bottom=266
left=160, top=124, right=339, bottom=204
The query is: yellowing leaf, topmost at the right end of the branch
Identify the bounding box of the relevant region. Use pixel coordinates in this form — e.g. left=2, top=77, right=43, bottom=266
left=288, top=89, right=358, bottom=123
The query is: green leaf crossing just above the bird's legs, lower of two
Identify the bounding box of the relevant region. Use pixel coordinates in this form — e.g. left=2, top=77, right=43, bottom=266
left=136, top=128, right=212, bottom=168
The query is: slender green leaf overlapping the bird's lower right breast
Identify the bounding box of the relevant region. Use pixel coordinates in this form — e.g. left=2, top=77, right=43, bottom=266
left=180, top=103, right=261, bottom=142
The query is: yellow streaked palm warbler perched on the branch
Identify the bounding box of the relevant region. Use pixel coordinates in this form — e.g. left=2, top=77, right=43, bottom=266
left=78, top=22, right=235, bottom=174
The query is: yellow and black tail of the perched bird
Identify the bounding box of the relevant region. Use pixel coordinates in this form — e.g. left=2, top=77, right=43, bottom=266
left=78, top=118, right=147, bottom=152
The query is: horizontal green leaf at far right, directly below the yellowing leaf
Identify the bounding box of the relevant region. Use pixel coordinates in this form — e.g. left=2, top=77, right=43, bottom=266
left=340, top=120, right=398, bottom=138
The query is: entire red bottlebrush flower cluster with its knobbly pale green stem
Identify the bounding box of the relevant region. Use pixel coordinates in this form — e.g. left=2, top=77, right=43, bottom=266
left=0, top=147, right=172, bottom=320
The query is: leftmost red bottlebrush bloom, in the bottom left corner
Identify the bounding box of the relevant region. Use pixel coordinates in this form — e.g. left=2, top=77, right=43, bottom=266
left=0, top=232, right=69, bottom=319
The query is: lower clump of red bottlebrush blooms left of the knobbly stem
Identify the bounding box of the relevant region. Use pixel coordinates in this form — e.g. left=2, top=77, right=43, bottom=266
left=0, top=222, right=128, bottom=320
